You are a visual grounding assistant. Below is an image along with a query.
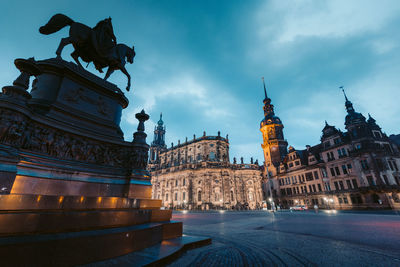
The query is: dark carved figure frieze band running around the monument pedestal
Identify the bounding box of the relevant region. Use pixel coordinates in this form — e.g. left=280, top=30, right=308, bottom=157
left=0, top=109, right=138, bottom=169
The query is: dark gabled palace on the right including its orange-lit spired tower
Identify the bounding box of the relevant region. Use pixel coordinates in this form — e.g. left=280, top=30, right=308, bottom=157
left=260, top=84, right=400, bottom=209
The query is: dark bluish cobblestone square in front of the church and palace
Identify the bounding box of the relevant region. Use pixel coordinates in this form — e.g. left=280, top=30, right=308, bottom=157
left=170, top=211, right=400, bottom=266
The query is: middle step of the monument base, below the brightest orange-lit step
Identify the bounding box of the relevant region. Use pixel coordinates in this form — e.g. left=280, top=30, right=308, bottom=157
left=0, top=209, right=172, bottom=236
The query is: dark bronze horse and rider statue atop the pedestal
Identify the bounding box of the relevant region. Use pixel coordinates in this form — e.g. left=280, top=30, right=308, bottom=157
left=39, top=14, right=136, bottom=91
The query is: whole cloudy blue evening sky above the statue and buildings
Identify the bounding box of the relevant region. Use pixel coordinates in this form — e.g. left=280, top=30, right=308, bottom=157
left=0, top=0, right=400, bottom=162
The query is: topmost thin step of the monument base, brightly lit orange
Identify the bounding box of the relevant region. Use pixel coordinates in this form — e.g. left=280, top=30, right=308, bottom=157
left=0, top=194, right=161, bottom=211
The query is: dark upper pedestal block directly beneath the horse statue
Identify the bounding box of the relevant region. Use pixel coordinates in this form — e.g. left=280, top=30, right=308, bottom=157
left=29, top=59, right=129, bottom=141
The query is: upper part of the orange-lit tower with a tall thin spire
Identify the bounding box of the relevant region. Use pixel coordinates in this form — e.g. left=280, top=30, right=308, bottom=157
left=260, top=78, right=288, bottom=170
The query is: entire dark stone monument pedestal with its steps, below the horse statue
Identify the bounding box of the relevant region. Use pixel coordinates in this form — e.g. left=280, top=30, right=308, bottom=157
left=0, top=59, right=211, bottom=266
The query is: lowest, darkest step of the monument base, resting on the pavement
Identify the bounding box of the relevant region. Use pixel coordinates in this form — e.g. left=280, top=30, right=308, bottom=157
left=0, top=222, right=182, bottom=266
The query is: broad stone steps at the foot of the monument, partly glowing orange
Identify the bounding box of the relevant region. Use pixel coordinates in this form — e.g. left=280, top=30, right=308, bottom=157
left=0, top=194, right=182, bottom=266
